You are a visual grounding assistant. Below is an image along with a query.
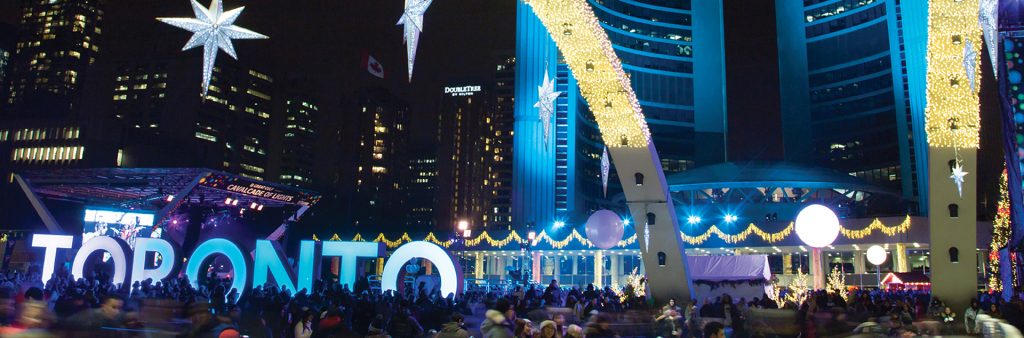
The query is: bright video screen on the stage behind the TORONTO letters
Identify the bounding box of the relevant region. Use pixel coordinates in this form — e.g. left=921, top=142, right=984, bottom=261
left=82, top=209, right=164, bottom=246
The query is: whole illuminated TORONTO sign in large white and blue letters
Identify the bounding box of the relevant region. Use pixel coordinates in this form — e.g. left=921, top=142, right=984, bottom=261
left=32, top=235, right=463, bottom=295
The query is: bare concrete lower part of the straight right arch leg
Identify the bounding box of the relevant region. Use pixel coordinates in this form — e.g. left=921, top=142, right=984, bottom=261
left=928, top=146, right=978, bottom=308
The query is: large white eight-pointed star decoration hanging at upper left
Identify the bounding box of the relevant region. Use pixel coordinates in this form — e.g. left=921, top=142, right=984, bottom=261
left=157, top=0, right=267, bottom=96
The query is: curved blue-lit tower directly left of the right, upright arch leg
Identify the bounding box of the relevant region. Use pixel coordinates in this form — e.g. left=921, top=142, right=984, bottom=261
left=775, top=0, right=928, bottom=212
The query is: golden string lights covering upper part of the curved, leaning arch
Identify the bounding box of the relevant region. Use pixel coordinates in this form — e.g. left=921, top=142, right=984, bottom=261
left=526, top=0, right=650, bottom=147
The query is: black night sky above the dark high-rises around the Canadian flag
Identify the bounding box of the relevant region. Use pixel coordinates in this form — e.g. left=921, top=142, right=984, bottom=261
left=0, top=0, right=515, bottom=143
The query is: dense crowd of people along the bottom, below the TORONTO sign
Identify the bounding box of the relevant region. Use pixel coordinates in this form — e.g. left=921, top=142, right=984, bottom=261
left=0, top=266, right=1024, bottom=338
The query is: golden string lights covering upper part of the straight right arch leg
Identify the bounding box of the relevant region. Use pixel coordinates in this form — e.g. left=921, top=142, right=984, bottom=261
left=925, top=0, right=981, bottom=149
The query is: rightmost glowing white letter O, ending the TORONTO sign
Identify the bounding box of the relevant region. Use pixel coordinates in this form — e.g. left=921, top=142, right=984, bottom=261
left=381, top=241, right=463, bottom=297
